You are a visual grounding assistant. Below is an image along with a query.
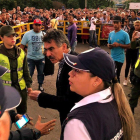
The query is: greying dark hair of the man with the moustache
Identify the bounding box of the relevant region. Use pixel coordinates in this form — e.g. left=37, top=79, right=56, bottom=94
left=43, top=29, right=70, bottom=48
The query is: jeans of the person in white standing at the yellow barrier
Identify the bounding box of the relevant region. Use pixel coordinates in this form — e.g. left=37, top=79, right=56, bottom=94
left=89, top=30, right=98, bottom=47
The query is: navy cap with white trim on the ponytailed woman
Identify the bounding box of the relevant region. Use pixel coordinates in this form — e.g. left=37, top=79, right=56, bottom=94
left=64, top=47, right=115, bottom=82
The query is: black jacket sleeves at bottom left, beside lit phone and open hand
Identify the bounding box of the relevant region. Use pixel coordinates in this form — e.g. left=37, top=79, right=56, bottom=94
left=9, top=110, right=34, bottom=140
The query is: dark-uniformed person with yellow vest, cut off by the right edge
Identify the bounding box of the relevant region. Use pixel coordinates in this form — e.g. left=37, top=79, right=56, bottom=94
left=129, top=21, right=140, bottom=113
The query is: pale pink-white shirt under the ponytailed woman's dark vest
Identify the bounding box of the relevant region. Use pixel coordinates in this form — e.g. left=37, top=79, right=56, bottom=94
left=64, top=88, right=114, bottom=140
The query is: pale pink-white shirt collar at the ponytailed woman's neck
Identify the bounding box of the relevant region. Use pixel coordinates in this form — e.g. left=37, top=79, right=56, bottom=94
left=70, top=87, right=114, bottom=112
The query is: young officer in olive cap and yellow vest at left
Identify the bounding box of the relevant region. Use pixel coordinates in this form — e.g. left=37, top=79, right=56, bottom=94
left=0, top=25, right=32, bottom=114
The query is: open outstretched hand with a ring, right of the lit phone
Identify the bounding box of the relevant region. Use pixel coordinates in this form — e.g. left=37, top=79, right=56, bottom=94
left=35, top=115, right=56, bottom=136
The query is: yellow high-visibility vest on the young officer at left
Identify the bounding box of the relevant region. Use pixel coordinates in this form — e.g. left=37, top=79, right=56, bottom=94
left=0, top=49, right=26, bottom=90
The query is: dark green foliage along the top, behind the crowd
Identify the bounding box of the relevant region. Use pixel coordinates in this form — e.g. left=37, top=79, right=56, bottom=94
left=0, top=0, right=115, bottom=10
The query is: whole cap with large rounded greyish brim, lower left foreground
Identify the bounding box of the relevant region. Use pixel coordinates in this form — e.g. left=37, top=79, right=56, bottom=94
left=0, top=80, right=21, bottom=117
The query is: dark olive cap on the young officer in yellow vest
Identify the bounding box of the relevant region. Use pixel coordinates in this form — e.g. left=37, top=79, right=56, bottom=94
left=0, top=25, right=16, bottom=36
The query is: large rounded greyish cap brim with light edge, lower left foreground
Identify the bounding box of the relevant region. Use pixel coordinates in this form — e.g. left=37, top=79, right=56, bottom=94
left=4, top=86, right=21, bottom=111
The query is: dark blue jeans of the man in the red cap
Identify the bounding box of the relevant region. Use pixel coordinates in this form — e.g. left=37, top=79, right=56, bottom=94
left=27, top=58, right=45, bottom=84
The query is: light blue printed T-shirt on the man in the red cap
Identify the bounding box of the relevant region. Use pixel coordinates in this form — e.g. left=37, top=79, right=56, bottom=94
left=21, top=30, right=44, bottom=60
